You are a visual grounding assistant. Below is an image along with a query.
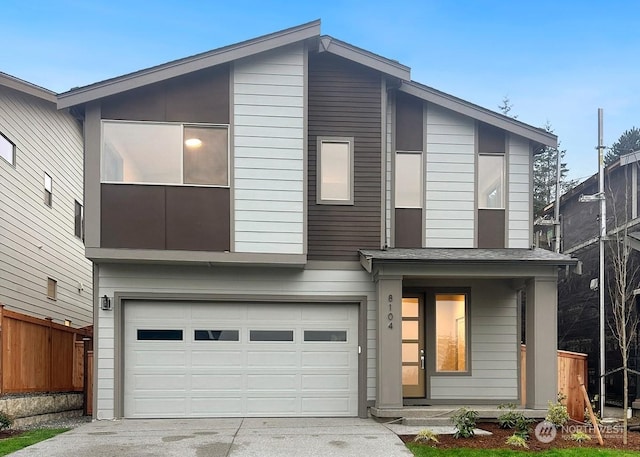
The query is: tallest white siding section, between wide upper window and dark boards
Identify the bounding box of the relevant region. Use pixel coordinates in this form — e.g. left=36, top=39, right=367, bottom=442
left=233, top=43, right=304, bottom=254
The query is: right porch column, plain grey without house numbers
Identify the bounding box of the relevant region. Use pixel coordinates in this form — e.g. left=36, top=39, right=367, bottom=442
left=525, top=277, right=558, bottom=409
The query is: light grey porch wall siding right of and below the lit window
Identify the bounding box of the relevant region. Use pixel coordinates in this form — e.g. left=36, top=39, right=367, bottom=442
left=430, top=281, right=520, bottom=401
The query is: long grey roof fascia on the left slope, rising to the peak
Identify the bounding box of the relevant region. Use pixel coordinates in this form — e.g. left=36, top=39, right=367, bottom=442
left=58, top=20, right=320, bottom=109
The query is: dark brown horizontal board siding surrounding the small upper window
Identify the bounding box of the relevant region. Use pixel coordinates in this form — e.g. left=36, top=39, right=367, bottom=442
left=307, top=54, right=382, bottom=260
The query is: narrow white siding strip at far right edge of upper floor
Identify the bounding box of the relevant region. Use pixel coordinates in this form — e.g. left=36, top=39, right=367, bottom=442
left=507, top=135, right=533, bottom=248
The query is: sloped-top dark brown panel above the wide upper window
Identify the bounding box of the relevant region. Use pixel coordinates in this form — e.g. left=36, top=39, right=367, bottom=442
left=102, top=65, right=229, bottom=124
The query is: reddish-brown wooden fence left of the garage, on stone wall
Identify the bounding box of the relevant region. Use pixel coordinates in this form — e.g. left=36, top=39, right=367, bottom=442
left=0, top=305, right=91, bottom=394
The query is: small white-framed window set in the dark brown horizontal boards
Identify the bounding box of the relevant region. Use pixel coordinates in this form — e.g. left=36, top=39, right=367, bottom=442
left=316, top=137, right=353, bottom=205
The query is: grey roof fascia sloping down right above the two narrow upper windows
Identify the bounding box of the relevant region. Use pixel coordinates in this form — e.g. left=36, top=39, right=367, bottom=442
left=399, top=81, right=558, bottom=148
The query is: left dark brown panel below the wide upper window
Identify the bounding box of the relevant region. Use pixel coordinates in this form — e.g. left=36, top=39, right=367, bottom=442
left=100, top=184, right=165, bottom=249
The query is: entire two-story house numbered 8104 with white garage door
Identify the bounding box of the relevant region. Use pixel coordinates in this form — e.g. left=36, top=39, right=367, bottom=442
left=58, top=21, right=575, bottom=419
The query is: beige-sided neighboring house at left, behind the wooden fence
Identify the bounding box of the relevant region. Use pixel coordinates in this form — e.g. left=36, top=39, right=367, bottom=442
left=0, top=73, right=93, bottom=327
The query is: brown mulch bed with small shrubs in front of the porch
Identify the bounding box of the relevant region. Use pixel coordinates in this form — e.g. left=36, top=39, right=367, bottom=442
left=400, top=422, right=640, bottom=451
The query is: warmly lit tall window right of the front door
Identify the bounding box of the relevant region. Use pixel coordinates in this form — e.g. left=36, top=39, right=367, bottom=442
left=435, top=294, right=468, bottom=372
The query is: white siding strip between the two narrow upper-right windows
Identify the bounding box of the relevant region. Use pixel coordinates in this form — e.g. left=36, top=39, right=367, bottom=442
left=425, top=104, right=475, bottom=248
